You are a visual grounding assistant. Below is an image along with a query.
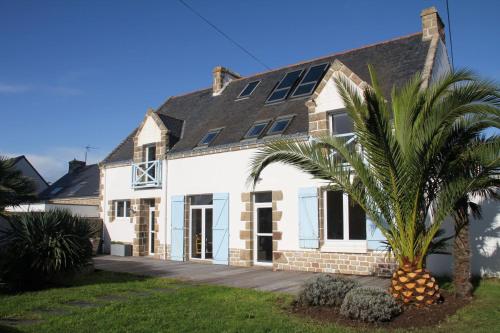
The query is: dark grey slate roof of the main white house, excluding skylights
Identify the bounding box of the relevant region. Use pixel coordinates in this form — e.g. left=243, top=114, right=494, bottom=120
left=103, top=33, right=430, bottom=163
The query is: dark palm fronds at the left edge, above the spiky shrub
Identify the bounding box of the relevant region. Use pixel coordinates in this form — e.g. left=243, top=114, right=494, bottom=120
left=0, top=156, right=36, bottom=215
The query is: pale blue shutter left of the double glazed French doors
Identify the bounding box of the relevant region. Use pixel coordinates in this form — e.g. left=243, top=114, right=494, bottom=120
left=170, top=195, right=184, bottom=261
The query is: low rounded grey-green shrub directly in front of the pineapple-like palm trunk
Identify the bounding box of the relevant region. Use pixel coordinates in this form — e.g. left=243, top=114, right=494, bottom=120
left=340, top=287, right=402, bottom=322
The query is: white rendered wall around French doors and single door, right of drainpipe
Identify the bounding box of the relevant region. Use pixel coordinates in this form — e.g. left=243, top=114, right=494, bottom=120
left=167, top=149, right=326, bottom=250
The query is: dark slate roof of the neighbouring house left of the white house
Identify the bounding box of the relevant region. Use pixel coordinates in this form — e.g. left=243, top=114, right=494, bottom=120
left=39, top=164, right=100, bottom=200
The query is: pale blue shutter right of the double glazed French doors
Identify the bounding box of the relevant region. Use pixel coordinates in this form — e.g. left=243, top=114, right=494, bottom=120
left=212, top=193, right=229, bottom=265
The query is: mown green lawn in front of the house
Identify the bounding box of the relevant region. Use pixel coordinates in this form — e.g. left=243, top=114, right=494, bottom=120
left=0, top=272, right=500, bottom=333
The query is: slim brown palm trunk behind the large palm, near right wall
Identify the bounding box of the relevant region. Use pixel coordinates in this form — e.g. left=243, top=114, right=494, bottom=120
left=453, top=214, right=472, bottom=297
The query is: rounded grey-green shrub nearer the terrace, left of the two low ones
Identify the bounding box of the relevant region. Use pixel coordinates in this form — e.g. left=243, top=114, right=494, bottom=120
left=298, top=274, right=359, bottom=306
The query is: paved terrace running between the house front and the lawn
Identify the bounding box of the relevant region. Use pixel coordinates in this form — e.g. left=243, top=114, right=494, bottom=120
left=94, top=256, right=389, bottom=294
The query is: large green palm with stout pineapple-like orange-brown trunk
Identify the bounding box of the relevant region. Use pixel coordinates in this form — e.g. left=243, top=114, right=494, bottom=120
left=249, top=66, right=500, bottom=305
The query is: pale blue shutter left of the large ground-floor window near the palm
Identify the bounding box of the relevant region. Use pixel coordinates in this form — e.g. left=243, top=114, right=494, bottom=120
left=299, top=187, right=319, bottom=249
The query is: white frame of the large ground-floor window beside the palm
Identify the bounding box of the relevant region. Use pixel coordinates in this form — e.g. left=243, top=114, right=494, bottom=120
left=321, top=190, right=368, bottom=253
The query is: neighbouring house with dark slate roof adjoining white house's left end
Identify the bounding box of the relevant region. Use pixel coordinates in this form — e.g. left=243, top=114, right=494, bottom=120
left=7, top=160, right=99, bottom=218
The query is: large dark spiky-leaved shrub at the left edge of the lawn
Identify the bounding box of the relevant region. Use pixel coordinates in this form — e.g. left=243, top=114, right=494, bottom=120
left=0, top=210, right=94, bottom=289
